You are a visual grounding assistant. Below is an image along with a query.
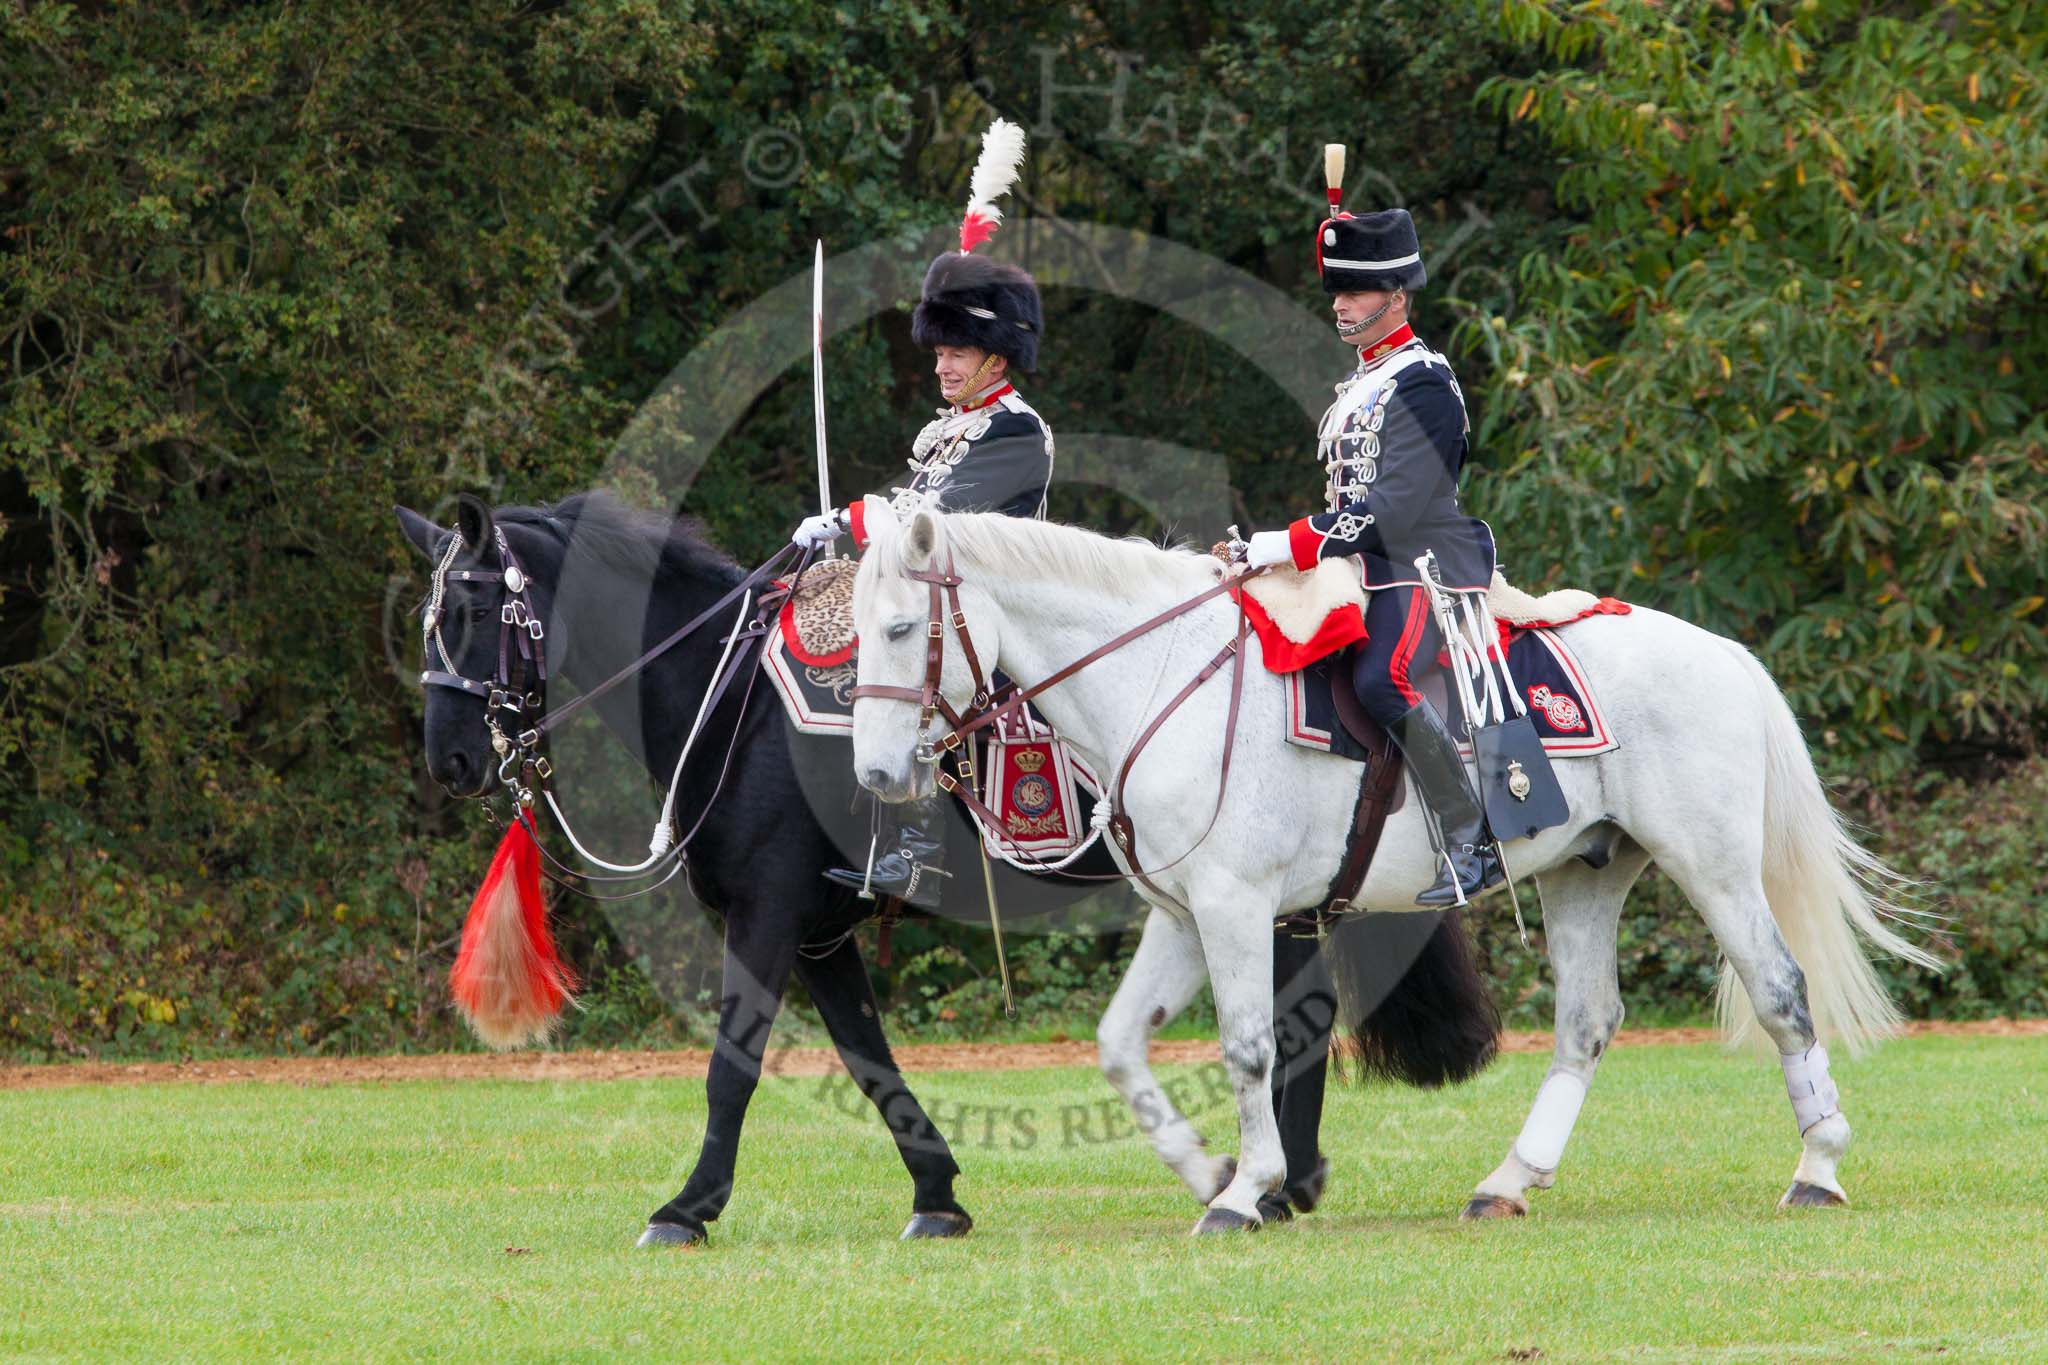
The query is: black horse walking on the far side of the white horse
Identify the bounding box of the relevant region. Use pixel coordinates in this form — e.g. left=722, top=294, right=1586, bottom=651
left=397, top=493, right=1499, bottom=1246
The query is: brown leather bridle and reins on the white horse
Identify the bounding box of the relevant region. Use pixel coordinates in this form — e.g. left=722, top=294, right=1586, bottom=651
left=852, top=551, right=1264, bottom=900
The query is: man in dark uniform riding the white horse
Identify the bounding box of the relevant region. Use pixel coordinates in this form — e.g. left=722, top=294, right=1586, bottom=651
left=1245, top=145, right=1501, bottom=907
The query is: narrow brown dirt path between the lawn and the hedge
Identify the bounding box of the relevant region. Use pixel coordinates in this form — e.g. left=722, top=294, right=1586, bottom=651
left=0, top=1019, right=2048, bottom=1091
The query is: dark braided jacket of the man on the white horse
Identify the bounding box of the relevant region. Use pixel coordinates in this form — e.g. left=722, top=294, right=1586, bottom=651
left=1288, top=323, right=1493, bottom=589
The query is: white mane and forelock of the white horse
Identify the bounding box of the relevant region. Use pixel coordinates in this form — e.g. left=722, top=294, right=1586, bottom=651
left=870, top=512, right=1219, bottom=596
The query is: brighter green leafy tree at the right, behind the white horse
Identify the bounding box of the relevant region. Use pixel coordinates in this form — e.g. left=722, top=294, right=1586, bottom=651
left=1468, top=0, right=2048, bottom=769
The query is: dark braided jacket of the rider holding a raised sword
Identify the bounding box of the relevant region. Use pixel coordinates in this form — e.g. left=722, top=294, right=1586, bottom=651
left=848, top=385, right=1053, bottom=551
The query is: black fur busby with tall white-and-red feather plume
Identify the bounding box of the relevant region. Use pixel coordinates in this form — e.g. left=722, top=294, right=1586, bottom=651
left=909, top=119, right=1044, bottom=370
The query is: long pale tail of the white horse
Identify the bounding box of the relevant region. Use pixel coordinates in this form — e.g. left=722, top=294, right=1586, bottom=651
left=1718, top=647, right=1942, bottom=1052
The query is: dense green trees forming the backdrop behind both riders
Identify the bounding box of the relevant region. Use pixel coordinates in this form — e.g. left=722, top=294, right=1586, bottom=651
left=0, top=0, right=2023, bottom=1056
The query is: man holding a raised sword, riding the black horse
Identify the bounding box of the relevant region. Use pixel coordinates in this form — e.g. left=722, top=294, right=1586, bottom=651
left=791, top=119, right=1053, bottom=898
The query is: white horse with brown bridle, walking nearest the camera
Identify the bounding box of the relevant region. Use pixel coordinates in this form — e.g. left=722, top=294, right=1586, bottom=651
left=854, top=508, right=1933, bottom=1232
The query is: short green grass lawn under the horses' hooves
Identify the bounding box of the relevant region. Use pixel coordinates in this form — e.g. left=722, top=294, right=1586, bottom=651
left=0, top=1038, right=2048, bottom=1361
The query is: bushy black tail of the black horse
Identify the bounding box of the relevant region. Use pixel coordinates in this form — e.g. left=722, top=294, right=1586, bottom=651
left=1323, top=911, right=1501, bottom=1089
